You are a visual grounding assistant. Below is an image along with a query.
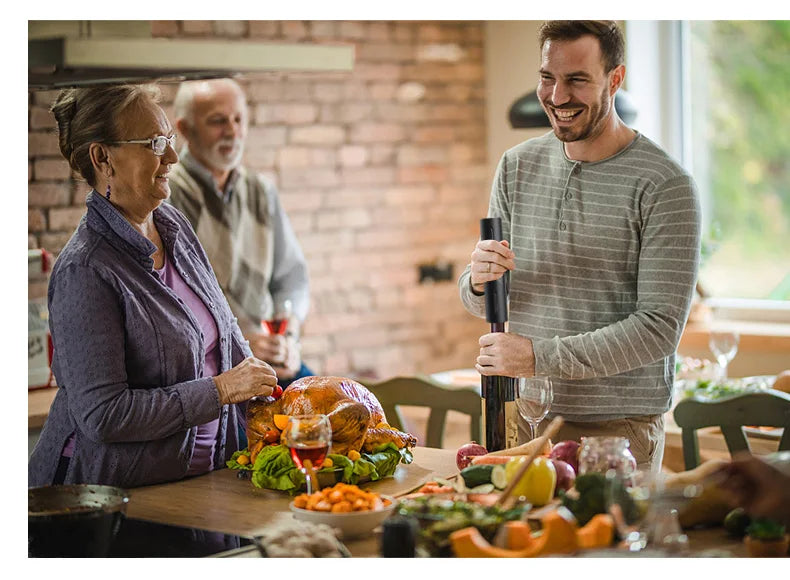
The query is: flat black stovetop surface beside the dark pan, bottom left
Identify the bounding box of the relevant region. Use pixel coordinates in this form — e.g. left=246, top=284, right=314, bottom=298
left=109, top=518, right=254, bottom=558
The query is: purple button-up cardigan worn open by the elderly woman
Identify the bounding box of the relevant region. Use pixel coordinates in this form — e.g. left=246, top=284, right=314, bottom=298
left=28, top=191, right=251, bottom=487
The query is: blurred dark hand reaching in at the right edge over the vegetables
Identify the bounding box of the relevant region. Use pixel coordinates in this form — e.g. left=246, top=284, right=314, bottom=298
left=716, top=453, right=790, bottom=525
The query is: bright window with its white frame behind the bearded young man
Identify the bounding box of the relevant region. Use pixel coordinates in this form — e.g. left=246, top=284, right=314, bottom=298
left=626, top=20, right=790, bottom=306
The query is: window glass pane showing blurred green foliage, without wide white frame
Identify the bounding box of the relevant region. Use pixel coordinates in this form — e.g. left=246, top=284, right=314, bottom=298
left=681, top=20, right=790, bottom=300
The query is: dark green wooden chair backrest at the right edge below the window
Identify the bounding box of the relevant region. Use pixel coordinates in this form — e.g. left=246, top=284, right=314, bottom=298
left=674, top=390, right=790, bottom=469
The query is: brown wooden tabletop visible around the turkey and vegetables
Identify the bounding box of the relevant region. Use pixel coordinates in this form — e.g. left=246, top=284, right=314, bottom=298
left=127, top=447, right=746, bottom=557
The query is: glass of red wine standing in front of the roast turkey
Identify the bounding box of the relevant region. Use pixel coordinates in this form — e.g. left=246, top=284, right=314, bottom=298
left=283, top=415, right=332, bottom=493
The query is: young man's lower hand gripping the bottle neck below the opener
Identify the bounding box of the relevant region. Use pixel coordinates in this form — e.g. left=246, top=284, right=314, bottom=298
left=475, top=332, right=535, bottom=377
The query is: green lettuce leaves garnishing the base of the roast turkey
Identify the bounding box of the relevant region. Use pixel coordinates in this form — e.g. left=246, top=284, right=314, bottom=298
left=227, top=443, right=413, bottom=494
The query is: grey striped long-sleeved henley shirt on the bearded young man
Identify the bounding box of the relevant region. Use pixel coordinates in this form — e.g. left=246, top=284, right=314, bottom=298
left=458, top=132, right=700, bottom=421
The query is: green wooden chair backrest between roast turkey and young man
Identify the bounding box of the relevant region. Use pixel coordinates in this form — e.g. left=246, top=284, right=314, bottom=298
left=362, top=375, right=482, bottom=448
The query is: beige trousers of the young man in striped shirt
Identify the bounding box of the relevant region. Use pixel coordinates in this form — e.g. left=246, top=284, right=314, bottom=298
left=519, top=415, right=664, bottom=475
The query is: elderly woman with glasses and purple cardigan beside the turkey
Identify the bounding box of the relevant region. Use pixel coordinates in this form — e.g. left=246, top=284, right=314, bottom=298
left=28, top=85, right=277, bottom=487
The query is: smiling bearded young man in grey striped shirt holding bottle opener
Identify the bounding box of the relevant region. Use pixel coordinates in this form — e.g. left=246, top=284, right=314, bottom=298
left=458, top=20, right=700, bottom=472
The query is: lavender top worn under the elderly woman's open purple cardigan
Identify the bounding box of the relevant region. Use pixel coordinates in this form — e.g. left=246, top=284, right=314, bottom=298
left=156, top=254, right=219, bottom=475
